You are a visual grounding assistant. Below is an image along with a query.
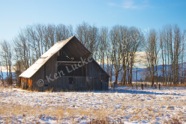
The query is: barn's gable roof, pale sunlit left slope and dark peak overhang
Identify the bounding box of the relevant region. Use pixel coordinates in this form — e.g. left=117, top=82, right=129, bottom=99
left=19, top=36, right=108, bottom=78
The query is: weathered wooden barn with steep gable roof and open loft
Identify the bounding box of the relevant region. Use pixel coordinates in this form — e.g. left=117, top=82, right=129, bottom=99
left=19, top=36, right=109, bottom=91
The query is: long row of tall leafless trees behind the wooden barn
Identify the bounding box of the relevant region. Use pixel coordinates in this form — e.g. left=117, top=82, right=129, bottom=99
left=0, top=22, right=186, bottom=86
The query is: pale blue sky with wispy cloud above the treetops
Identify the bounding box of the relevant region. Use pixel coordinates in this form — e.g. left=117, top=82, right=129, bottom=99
left=0, top=0, right=186, bottom=41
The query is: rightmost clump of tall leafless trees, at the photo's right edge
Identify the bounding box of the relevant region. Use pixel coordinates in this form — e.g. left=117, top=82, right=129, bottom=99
left=160, top=26, right=185, bottom=84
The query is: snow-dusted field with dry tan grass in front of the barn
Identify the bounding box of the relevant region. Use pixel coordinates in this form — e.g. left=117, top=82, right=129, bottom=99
left=0, top=87, right=186, bottom=124
